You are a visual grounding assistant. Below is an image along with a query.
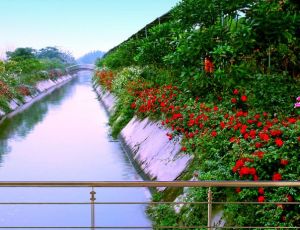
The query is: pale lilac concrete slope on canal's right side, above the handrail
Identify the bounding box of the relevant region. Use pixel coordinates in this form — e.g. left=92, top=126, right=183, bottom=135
left=94, top=86, right=192, bottom=185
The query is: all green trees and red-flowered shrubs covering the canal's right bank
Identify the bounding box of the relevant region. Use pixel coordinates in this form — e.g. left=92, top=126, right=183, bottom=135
left=95, top=0, right=300, bottom=227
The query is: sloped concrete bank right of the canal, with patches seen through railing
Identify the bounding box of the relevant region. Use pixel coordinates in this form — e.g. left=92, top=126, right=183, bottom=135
left=94, top=85, right=225, bottom=227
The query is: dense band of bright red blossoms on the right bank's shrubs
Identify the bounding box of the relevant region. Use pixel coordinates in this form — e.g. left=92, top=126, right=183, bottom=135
left=131, top=86, right=300, bottom=202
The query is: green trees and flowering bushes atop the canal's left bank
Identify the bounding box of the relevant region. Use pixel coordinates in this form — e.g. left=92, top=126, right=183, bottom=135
left=0, top=47, right=75, bottom=113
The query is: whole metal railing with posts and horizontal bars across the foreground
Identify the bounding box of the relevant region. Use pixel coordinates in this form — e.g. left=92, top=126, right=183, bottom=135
left=0, top=181, right=300, bottom=229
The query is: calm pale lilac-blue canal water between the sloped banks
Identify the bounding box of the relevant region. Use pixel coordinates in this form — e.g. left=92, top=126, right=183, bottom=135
left=0, top=72, right=151, bottom=227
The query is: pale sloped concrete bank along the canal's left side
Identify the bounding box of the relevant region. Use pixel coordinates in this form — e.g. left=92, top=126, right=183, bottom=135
left=0, top=75, right=75, bottom=124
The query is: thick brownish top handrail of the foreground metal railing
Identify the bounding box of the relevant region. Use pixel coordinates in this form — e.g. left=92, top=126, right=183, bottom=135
left=0, top=181, right=300, bottom=187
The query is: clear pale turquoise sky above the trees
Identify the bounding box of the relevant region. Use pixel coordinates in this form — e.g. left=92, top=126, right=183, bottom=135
left=0, top=0, right=180, bottom=58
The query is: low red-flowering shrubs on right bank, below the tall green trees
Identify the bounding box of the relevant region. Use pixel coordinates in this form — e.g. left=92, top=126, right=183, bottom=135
left=97, top=69, right=300, bottom=226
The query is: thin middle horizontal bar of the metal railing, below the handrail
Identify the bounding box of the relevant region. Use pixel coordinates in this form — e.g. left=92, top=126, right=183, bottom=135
left=0, top=201, right=300, bottom=205
